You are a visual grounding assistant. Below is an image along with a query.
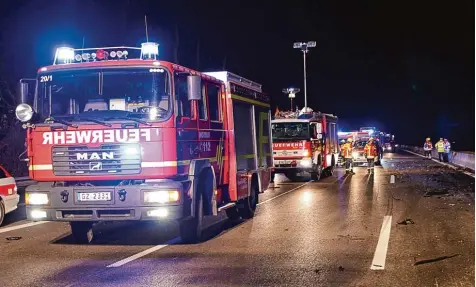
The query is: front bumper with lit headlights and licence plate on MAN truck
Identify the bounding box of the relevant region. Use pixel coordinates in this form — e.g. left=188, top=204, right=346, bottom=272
left=25, top=180, right=190, bottom=222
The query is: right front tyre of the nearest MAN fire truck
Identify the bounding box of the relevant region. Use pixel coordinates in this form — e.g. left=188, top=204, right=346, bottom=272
left=180, top=193, right=203, bottom=243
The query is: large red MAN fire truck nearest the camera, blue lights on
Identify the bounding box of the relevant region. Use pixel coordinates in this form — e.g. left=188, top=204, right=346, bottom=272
left=16, top=43, right=272, bottom=243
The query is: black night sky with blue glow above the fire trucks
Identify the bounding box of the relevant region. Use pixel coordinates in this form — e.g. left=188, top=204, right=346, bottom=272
left=0, top=0, right=475, bottom=150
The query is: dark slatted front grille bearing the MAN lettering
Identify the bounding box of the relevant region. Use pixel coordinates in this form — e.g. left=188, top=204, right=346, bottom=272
left=52, top=144, right=141, bottom=175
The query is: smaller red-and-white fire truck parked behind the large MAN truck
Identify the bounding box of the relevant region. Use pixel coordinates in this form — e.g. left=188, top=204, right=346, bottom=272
left=271, top=108, right=339, bottom=180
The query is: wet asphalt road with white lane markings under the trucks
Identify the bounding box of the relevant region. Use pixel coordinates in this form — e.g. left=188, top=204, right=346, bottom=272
left=0, top=153, right=475, bottom=287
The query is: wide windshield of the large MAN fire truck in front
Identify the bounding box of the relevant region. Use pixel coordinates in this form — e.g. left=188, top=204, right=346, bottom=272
left=35, top=69, right=172, bottom=121
